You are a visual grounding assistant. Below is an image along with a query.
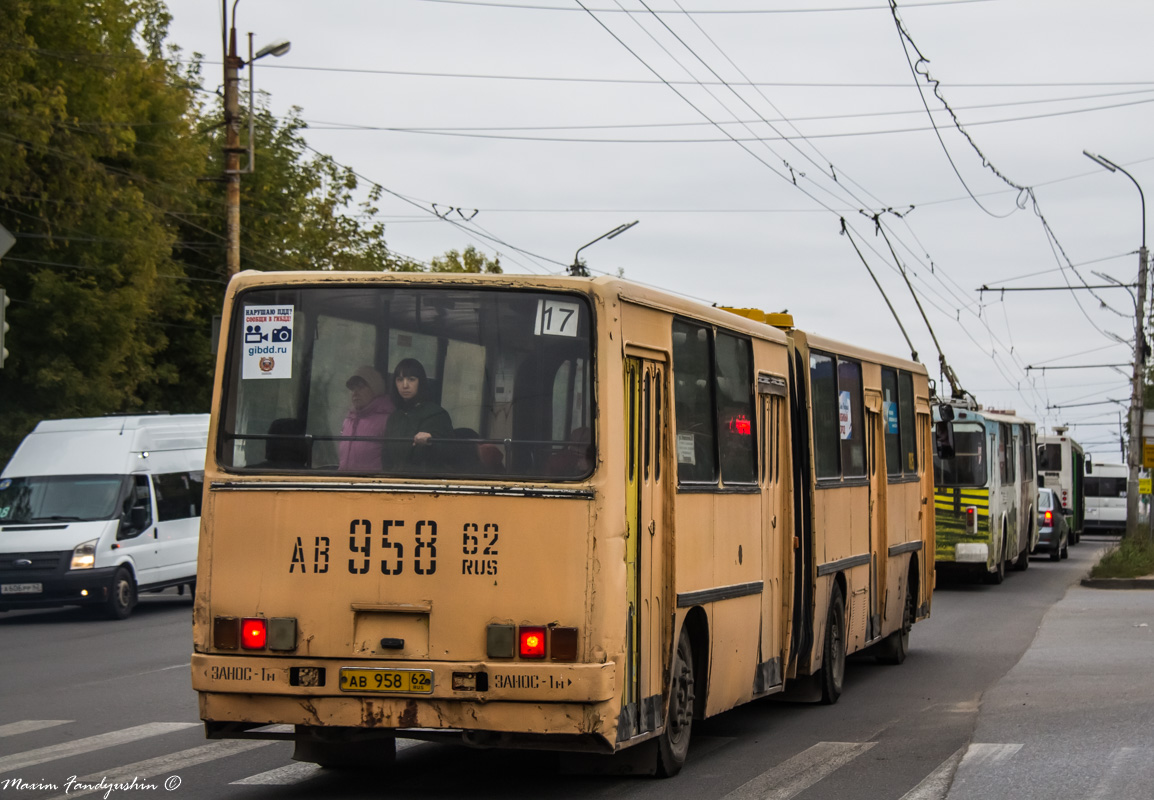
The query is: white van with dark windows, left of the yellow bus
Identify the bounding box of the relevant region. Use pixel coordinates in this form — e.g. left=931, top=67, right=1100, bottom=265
left=0, top=414, right=209, bottom=620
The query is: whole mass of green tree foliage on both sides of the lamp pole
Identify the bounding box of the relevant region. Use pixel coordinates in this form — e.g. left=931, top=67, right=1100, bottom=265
left=0, top=0, right=491, bottom=463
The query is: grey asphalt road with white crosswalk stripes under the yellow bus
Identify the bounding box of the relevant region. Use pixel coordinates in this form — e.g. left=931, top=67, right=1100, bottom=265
left=0, top=539, right=1127, bottom=800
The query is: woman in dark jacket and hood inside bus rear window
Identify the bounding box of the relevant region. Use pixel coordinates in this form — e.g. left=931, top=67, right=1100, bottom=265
left=381, top=358, right=452, bottom=472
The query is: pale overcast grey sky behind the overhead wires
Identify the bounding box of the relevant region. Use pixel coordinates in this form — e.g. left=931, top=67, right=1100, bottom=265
left=167, top=0, right=1154, bottom=461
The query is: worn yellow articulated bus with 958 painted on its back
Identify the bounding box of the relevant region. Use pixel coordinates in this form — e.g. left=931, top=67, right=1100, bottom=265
left=192, top=272, right=935, bottom=776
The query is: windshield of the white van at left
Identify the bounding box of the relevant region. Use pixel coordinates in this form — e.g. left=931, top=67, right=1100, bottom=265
left=0, top=474, right=128, bottom=524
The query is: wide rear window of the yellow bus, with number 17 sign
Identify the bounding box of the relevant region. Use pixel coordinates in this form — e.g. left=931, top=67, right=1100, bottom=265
left=216, top=284, right=595, bottom=480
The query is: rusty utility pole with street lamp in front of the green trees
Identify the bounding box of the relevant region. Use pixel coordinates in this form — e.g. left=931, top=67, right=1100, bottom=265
left=220, top=0, right=292, bottom=277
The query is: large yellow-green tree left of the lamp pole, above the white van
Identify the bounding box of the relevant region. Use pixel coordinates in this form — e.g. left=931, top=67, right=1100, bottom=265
left=0, top=0, right=205, bottom=455
